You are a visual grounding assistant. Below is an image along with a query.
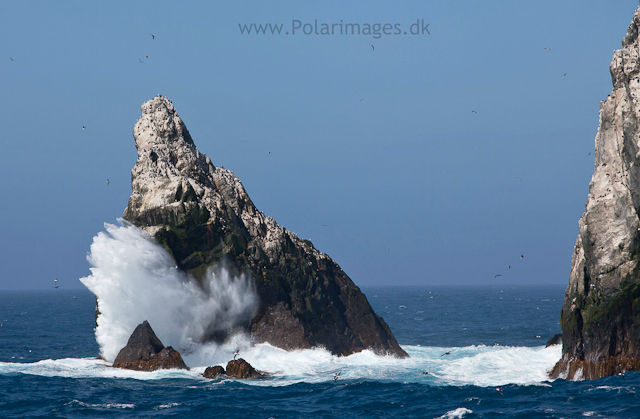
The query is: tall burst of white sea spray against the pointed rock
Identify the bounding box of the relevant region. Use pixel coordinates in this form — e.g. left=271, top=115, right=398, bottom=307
left=80, top=223, right=258, bottom=366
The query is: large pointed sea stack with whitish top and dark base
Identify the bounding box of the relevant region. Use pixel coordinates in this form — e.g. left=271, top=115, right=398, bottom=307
left=124, top=96, right=407, bottom=356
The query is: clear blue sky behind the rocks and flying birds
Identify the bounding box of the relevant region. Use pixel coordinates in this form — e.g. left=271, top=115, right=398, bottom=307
left=0, top=0, right=638, bottom=289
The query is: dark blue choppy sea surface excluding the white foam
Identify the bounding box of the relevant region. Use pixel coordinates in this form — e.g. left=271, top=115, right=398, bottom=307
left=0, top=286, right=640, bottom=419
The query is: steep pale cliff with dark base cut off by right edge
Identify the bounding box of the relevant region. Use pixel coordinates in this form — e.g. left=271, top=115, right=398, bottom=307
left=551, top=9, right=640, bottom=379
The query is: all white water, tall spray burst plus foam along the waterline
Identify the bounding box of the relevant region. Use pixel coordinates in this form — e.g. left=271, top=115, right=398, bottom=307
left=60, top=224, right=561, bottom=388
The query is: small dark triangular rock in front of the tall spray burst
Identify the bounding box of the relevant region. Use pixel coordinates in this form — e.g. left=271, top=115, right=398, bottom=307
left=113, top=320, right=189, bottom=371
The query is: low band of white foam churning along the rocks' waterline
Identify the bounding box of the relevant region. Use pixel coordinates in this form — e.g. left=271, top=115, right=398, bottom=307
left=0, top=344, right=562, bottom=387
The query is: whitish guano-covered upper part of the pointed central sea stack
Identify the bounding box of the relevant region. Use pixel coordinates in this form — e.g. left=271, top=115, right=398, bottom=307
left=129, top=96, right=326, bottom=259
